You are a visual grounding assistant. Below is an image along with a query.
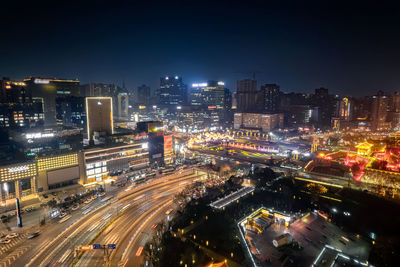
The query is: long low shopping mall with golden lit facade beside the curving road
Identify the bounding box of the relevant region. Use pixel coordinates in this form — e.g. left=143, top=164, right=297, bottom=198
left=0, top=138, right=171, bottom=201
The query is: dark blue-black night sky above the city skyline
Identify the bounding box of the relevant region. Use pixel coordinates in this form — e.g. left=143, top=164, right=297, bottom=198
left=0, top=1, right=400, bottom=95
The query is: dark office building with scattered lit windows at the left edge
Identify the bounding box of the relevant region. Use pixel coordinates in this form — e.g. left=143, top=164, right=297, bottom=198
left=0, top=78, right=44, bottom=128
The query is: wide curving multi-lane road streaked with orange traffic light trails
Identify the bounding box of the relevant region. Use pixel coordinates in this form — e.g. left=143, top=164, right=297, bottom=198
left=0, top=170, right=206, bottom=267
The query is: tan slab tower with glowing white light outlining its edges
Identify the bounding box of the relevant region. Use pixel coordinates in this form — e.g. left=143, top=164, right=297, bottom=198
left=86, top=97, right=114, bottom=140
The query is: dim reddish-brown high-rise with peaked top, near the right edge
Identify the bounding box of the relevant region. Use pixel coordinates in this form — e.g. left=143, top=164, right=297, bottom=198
left=371, top=91, right=390, bottom=131
